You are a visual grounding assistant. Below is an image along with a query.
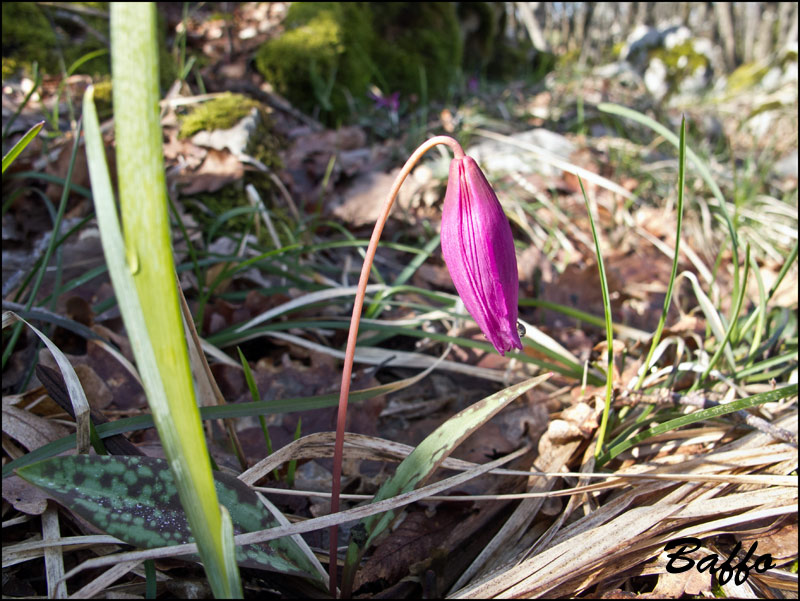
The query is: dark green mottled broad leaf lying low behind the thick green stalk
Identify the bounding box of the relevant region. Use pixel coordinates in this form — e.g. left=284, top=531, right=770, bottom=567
left=17, top=455, right=320, bottom=580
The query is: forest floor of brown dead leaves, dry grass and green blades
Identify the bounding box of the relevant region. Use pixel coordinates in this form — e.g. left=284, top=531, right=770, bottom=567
left=2, top=3, right=798, bottom=598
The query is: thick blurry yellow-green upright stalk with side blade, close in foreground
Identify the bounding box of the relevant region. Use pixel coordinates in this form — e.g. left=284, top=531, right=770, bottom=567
left=83, top=2, right=242, bottom=598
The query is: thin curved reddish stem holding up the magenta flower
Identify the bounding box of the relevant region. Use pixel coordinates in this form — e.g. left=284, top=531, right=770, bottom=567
left=328, top=136, right=464, bottom=599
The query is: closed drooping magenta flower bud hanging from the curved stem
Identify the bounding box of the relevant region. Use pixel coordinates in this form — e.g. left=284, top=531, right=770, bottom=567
left=442, top=156, right=522, bottom=355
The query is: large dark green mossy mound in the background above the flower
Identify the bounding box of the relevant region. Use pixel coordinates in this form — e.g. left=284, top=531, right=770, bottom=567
left=255, top=2, right=461, bottom=123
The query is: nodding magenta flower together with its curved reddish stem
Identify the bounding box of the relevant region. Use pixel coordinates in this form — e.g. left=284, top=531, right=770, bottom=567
left=329, top=136, right=522, bottom=597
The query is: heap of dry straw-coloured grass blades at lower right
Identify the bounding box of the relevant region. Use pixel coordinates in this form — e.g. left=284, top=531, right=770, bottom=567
left=449, top=410, right=798, bottom=599
